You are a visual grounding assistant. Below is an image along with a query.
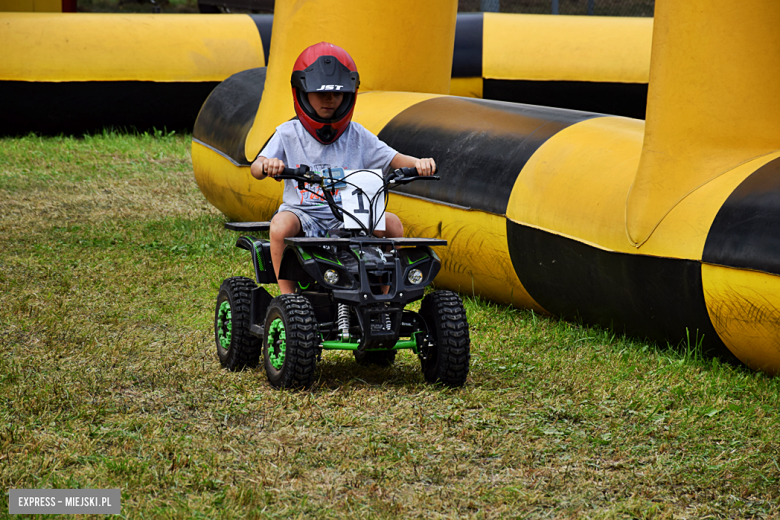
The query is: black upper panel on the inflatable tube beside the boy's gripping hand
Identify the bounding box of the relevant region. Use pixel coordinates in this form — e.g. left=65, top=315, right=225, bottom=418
left=379, top=97, right=599, bottom=215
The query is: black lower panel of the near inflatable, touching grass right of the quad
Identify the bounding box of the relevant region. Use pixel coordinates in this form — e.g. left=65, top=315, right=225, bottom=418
left=507, top=220, right=735, bottom=361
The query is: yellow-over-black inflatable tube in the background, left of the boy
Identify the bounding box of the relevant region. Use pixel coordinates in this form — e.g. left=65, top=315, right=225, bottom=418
left=0, top=13, right=272, bottom=135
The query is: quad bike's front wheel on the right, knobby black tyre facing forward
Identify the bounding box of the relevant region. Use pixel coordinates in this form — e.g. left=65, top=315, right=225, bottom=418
left=420, top=291, right=471, bottom=386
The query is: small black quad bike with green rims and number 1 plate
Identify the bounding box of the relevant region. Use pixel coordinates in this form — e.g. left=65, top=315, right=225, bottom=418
left=214, top=166, right=470, bottom=388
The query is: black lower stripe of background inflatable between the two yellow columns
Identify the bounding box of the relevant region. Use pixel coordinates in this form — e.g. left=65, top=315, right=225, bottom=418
left=482, top=79, right=647, bottom=119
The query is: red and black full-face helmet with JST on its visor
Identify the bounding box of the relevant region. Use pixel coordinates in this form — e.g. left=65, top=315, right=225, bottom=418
left=290, top=42, right=360, bottom=144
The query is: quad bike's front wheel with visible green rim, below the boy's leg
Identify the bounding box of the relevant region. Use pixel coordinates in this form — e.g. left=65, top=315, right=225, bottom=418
left=263, top=294, right=319, bottom=388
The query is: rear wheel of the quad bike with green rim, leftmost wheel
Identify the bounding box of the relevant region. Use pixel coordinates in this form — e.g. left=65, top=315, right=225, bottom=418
left=214, top=276, right=262, bottom=371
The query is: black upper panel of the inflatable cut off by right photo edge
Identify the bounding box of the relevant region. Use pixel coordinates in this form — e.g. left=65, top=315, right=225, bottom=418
left=702, top=155, right=780, bottom=274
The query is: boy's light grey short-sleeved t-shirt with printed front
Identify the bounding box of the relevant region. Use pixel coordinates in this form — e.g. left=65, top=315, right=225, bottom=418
left=258, top=120, right=398, bottom=219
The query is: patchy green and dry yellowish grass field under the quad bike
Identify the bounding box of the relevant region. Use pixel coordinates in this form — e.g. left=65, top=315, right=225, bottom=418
left=0, top=132, right=780, bottom=519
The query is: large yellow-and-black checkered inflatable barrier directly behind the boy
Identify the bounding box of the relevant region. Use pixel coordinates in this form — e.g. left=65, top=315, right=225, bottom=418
left=192, top=0, right=780, bottom=374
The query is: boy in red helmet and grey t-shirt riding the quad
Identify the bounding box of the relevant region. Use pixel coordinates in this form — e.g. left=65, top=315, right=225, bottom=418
left=251, top=42, right=436, bottom=294
